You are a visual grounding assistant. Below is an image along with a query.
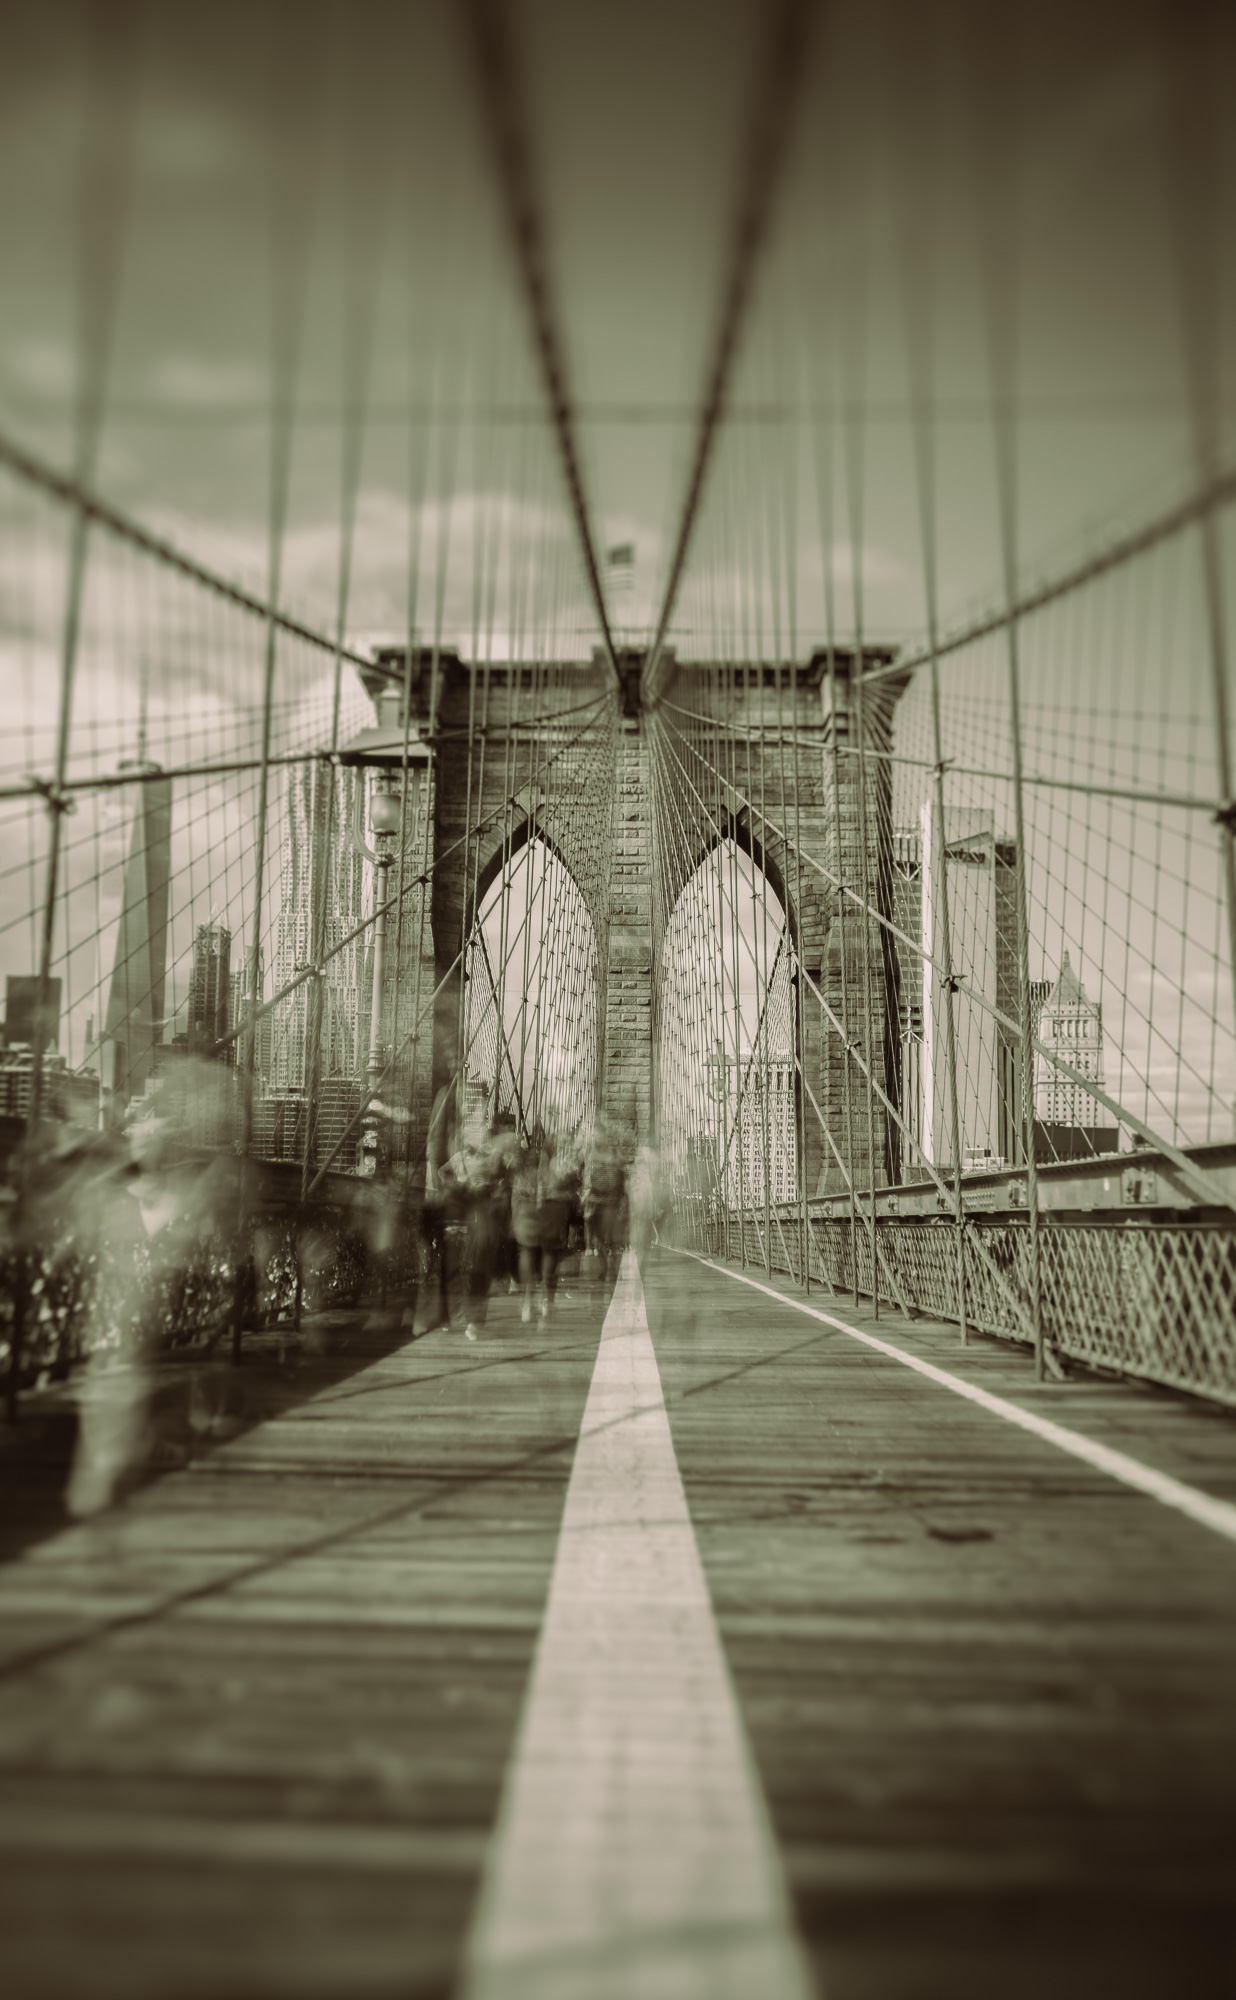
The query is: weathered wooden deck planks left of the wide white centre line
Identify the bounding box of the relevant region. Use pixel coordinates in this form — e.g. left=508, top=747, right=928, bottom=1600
left=0, top=1296, right=604, bottom=2000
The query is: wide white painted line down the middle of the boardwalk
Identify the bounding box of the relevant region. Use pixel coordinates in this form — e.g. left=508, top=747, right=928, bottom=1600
left=462, top=1252, right=814, bottom=2000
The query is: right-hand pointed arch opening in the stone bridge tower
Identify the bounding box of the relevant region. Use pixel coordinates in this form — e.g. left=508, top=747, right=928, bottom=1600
left=656, top=840, right=798, bottom=1214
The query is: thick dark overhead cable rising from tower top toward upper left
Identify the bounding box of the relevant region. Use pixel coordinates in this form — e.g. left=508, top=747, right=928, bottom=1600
left=466, top=0, right=618, bottom=674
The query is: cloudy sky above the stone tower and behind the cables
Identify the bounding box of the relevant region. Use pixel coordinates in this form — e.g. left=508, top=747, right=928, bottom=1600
left=0, top=0, right=1236, bottom=1144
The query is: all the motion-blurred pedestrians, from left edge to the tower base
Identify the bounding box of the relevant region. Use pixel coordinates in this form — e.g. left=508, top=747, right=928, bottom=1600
left=0, top=1076, right=660, bottom=1516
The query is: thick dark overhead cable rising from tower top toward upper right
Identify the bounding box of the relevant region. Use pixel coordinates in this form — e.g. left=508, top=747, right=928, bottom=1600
left=642, top=0, right=812, bottom=706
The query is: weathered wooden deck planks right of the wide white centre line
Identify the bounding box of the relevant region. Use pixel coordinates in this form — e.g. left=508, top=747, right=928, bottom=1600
left=646, top=1260, right=1236, bottom=2000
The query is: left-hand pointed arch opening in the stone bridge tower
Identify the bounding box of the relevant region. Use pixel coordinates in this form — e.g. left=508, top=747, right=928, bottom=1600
left=460, top=836, right=598, bottom=1138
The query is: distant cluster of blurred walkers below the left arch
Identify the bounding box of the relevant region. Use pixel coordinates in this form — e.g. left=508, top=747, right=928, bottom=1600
left=418, top=1084, right=658, bottom=1340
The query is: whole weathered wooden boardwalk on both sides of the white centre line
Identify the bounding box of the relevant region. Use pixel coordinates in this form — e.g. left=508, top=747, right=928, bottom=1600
left=0, top=1256, right=1236, bottom=2000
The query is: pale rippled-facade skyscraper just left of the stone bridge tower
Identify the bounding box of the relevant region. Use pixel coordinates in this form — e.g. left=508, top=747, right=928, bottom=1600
left=270, top=762, right=372, bottom=1094
